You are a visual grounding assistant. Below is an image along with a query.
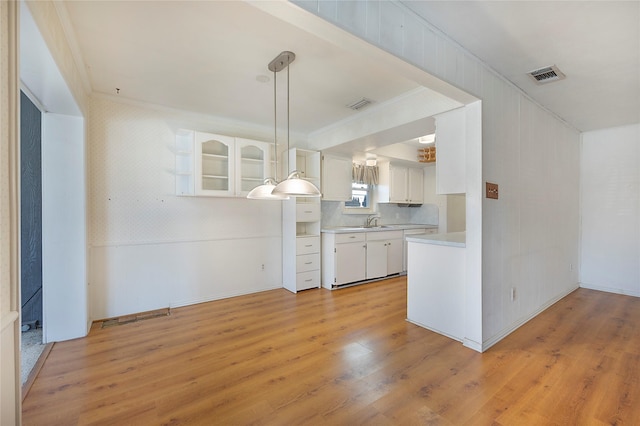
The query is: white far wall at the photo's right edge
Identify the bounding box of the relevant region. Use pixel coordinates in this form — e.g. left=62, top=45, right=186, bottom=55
left=580, top=124, right=640, bottom=296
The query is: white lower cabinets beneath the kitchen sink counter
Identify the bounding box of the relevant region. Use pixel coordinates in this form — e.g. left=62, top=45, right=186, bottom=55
left=322, top=231, right=403, bottom=289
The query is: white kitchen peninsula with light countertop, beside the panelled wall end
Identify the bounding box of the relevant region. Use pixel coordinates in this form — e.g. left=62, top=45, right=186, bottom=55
left=406, top=232, right=466, bottom=342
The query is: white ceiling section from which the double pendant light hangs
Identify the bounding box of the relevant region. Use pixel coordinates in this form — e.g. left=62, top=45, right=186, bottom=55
left=58, top=1, right=419, bottom=138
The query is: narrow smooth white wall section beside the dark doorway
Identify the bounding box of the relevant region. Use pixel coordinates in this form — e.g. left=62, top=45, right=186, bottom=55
left=42, top=113, right=89, bottom=343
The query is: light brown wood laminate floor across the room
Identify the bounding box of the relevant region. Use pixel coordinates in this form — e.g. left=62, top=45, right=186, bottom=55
left=23, top=277, right=640, bottom=426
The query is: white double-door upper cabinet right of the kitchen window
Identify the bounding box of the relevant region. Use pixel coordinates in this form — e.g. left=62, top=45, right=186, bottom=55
left=376, top=163, right=424, bottom=204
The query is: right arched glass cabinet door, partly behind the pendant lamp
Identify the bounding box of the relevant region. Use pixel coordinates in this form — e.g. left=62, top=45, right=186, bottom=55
left=235, top=138, right=273, bottom=196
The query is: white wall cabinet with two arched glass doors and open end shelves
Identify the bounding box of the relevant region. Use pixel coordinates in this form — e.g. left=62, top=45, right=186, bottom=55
left=176, top=130, right=271, bottom=197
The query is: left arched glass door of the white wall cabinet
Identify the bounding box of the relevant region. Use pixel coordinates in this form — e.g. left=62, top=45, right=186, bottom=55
left=195, top=132, right=234, bottom=196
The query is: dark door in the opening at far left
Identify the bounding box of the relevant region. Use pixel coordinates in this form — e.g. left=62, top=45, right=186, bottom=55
left=20, top=92, right=42, bottom=324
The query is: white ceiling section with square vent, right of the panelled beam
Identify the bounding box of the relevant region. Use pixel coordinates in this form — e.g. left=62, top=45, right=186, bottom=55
left=402, top=0, right=640, bottom=131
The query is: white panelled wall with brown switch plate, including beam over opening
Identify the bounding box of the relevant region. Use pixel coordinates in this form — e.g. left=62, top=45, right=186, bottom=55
left=294, top=1, right=579, bottom=350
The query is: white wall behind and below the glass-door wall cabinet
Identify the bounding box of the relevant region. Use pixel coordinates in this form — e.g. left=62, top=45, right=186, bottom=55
left=88, top=97, right=282, bottom=319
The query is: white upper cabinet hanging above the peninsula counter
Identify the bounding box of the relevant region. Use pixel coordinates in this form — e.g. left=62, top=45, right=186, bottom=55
left=435, top=108, right=466, bottom=194
